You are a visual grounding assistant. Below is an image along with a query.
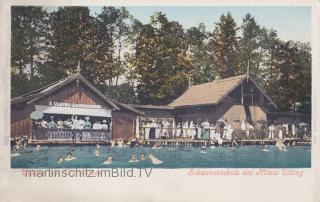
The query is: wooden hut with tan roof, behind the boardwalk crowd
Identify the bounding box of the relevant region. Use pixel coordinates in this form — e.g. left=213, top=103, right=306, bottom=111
left=133, top=74, right=277, bottom=128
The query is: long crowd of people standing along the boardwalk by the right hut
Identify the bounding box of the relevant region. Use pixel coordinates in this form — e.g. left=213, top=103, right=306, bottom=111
left=140, top=119, right=310, bottom=141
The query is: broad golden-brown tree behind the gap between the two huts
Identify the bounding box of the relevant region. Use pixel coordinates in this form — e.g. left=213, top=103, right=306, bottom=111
left=134, top=13, right=191, bottom=104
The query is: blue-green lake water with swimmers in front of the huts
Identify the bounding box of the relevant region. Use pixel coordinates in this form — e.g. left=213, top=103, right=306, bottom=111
left=11, top=146, right=311, bottom=168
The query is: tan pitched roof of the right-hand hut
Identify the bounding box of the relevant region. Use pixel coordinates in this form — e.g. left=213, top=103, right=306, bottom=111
left=169, top=74, right=276, bottom=107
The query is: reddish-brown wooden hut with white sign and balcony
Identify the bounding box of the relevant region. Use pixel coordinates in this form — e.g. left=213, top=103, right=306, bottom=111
left=11, top=74, right=143, bottom=143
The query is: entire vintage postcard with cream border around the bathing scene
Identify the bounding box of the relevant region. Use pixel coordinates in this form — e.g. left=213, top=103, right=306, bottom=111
left=0, top=1, right=320, bottom=201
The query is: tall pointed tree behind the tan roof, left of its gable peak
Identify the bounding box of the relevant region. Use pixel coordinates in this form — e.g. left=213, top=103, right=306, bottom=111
left=210, top=13, right=240, bottom=78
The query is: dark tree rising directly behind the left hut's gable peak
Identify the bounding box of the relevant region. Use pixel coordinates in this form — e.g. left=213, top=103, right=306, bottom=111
left=42, top=7, right=94, bottom=81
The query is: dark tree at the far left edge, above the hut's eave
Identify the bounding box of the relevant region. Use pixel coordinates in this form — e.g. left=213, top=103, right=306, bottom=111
left=11, top=6, right=49, bottom=96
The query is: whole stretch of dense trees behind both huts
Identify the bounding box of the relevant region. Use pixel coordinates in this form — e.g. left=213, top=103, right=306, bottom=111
left=11, top=6, right=311, bottom=113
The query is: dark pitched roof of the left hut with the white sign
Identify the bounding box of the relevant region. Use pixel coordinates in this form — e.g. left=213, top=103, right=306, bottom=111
left=11, top=74, right=143, bottom=114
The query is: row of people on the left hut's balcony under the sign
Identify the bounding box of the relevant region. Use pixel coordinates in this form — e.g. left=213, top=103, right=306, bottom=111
left=35, top=116, right=111, bottom=130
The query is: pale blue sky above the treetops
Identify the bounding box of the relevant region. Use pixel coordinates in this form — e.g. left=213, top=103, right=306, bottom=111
left=47, top=6, right=311, bottom=42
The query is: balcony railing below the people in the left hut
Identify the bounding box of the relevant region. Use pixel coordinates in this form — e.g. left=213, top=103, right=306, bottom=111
left=32, top=128, right=112, bottom=142
